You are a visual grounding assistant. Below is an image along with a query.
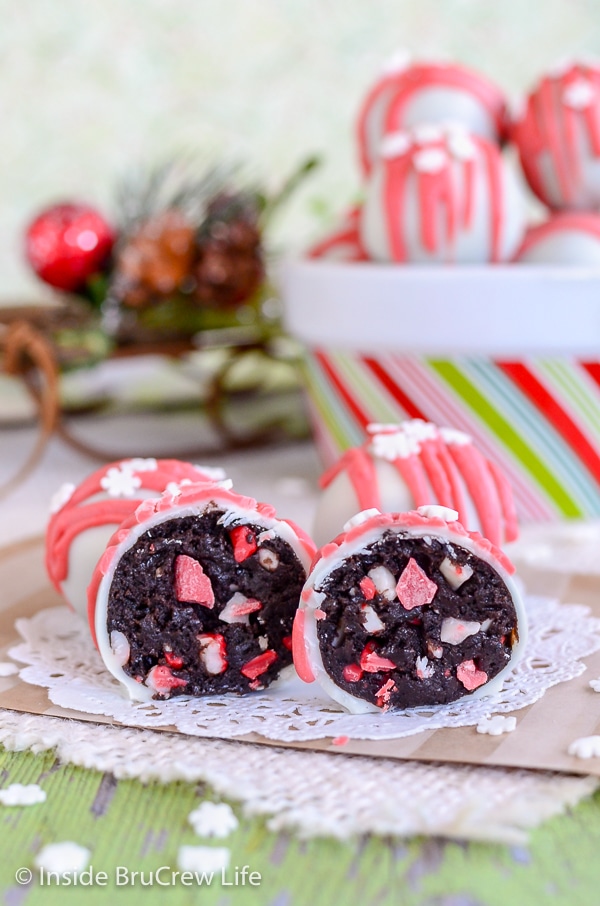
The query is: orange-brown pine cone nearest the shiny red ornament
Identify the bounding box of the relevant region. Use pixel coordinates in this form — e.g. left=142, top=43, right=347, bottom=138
left=113, top=208, right=194, bottom=308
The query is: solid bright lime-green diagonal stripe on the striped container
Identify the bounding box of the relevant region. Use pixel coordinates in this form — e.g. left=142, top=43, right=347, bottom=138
left=428, top=359, right=583, bottom=518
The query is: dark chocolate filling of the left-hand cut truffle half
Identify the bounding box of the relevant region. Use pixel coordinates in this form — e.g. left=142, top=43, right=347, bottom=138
left=107, top=509, right=306, bottom=697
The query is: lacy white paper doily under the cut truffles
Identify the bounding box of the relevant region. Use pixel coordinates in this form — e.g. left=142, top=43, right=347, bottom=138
left=9, top=597, right=600, bottom=742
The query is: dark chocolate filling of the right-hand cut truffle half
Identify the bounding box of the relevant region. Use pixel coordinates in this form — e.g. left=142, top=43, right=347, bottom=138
left=316, top=531, right=518, bottom=710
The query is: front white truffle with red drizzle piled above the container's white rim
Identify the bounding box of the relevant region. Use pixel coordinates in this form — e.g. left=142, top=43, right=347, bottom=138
left=360, top=127, right=525, bottom=265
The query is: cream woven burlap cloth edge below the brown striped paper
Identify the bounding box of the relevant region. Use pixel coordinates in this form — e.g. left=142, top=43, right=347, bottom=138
left=0, top=710, right=599, bottom=844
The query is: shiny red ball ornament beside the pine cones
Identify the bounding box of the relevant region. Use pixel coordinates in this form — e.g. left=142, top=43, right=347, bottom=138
left=25, top=203, right=115, bottom=292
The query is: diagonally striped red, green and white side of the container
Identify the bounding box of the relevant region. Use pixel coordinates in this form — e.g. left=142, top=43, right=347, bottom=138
left=305, top=349, right=600, bottom=522
